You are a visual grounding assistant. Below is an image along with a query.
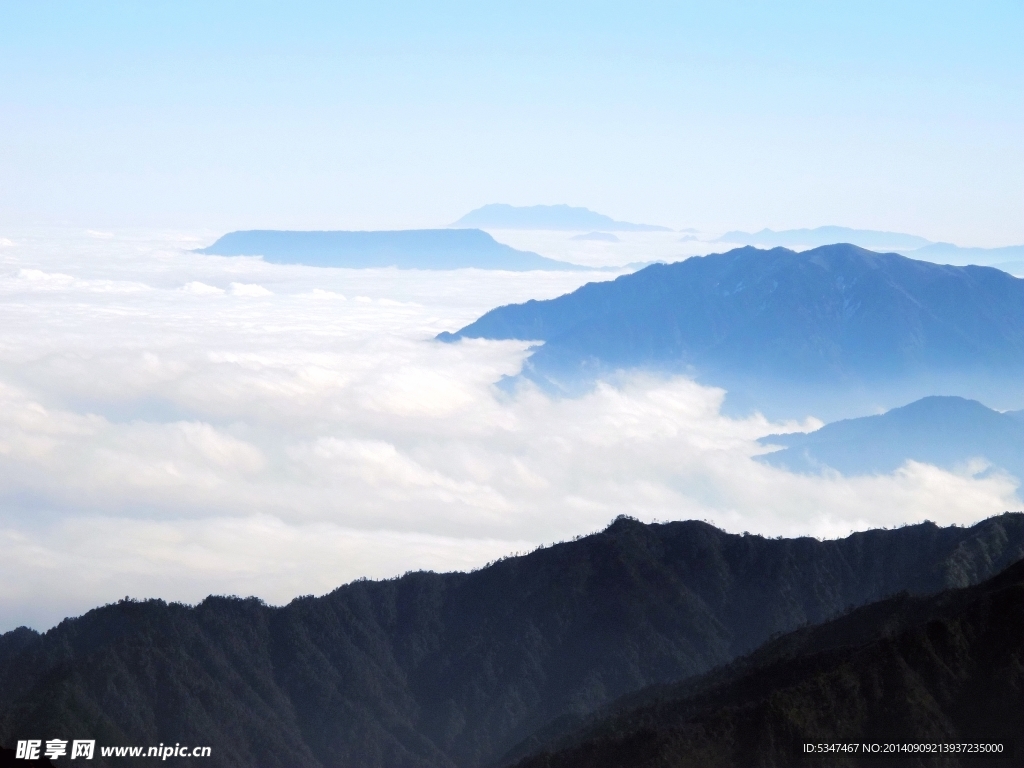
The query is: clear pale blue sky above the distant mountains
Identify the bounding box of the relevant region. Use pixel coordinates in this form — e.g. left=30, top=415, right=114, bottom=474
left=0, top=2, right=1024, bottom=246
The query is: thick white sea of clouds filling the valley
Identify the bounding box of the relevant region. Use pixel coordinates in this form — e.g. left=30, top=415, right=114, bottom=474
left=0, top=231, right=1020, bottom=631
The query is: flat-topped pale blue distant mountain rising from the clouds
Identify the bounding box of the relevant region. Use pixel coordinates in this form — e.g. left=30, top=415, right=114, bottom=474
left=199, top=229, right=589, bottom=271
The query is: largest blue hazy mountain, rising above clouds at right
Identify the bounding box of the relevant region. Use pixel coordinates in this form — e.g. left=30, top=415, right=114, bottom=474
left=438, top=244, right=1024, bottom=420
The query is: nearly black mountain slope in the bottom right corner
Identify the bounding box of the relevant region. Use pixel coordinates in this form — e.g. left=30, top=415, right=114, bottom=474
left=512, top=561, right=1024, bottom=768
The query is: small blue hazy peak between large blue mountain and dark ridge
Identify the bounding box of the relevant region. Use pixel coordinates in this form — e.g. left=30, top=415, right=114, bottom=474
left=758, top=396, right=1024, bottom=479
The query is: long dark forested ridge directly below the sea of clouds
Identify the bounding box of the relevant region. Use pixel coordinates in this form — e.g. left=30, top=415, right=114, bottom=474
left=0, top=513, right=1024, bottom=768
